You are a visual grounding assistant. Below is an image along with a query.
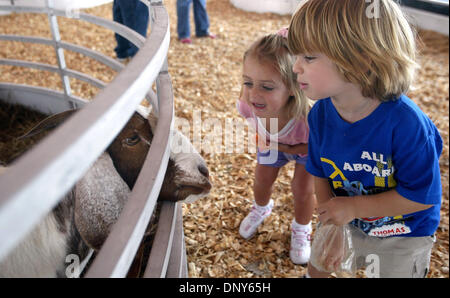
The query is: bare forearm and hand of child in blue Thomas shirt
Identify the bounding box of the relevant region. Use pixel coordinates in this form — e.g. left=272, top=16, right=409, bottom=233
left=317, top=190, right=433, bottom=225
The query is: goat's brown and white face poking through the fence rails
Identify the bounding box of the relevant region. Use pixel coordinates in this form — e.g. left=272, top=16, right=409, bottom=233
left=108, top=108, right=211, bottom=203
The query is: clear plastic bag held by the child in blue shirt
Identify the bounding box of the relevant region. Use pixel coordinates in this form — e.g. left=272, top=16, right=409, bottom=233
left=310, top=224, right=356, bottom=277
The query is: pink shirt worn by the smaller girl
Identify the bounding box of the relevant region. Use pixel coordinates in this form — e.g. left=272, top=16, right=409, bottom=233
left=236, top=100, right=309, bottom=157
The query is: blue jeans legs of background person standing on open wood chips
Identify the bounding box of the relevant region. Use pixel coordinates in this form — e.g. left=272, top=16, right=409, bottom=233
left=177, top=0, right=209, bottom=39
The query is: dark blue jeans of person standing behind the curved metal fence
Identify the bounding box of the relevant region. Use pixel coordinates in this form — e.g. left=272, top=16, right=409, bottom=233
left=113, top=0, right=148, bottom=58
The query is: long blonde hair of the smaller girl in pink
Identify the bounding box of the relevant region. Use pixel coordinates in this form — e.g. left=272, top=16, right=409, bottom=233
left=241, top=34, right=311, bottom=119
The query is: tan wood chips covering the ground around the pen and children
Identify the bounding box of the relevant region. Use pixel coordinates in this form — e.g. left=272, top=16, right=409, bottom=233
left=0, top=0, right=449, bottom=278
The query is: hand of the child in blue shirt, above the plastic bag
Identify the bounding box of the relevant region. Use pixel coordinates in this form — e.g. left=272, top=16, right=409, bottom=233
left=317, top=197, right=357, bottom=226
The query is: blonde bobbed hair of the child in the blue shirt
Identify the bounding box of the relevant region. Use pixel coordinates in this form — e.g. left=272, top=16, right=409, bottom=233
left=288, top=0, right=418, bottom=101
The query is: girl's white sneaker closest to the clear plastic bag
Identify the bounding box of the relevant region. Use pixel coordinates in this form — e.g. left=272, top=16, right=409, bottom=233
left=289, top=219, right=312, bottom=264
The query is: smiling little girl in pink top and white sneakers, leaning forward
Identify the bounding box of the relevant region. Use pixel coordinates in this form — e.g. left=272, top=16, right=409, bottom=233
left=237, top=29, right=315, bottom=264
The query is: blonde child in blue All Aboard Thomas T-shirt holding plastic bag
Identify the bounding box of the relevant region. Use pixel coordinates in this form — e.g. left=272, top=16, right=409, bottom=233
left=288, top=0, right=442, bottom=277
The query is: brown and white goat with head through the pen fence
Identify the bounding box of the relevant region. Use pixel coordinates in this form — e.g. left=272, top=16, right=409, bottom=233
left=0, top=107, right=211, bottom=277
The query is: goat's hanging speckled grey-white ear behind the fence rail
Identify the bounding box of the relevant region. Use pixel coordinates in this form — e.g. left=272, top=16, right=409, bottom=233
left=75, top=153, right=130, bottom=250
